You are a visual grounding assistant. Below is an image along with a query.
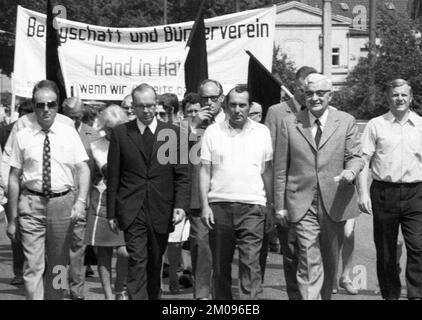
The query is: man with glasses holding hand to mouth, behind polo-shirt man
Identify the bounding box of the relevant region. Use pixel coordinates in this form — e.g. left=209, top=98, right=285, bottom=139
left=188, top=79, right=226, bottom=300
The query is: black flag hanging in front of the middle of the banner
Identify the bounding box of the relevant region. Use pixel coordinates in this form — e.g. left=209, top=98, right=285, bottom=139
left=185, top=0, right=208, bottom=93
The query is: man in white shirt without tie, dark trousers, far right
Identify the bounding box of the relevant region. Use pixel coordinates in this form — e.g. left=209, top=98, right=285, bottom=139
left=359, top=79, right=422, bottom=300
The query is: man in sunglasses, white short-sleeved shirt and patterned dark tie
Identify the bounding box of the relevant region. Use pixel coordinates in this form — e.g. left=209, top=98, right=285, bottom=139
left=7, top=80, right=90, bottom=300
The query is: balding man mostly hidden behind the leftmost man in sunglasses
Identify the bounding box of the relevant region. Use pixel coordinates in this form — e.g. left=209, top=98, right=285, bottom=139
left=62, top=97, right=100, bottom=300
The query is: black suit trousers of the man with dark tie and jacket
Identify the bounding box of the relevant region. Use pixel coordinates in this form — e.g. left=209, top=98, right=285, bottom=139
left=124, top=208, right=168, bottom=300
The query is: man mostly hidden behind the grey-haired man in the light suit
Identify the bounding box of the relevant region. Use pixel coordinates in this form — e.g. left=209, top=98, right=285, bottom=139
left=261, top=66, right=317, bottom=300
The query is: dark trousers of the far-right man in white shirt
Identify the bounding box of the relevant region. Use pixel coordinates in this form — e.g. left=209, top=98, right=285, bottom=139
left=371, top=181, right=422, bottom=299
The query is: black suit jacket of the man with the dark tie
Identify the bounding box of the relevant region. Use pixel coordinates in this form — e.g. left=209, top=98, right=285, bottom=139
left=107, top=120, right=190, bottom=234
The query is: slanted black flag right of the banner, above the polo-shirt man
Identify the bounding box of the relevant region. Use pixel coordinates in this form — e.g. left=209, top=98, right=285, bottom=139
left=246, top=50, right=282, bottom=119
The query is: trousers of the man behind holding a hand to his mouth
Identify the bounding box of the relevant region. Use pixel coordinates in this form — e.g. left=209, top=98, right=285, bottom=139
left=189, top=209, right=212, bottom=299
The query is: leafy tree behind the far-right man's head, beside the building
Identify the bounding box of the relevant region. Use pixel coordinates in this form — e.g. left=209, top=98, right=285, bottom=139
left=332, top=8, right=422, bottom=119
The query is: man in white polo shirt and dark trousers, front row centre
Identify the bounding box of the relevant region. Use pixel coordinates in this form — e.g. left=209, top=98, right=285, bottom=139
left=200, top=86, right=273, bottom=300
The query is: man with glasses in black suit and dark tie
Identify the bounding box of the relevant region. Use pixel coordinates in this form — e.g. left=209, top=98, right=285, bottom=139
left=107, top=84, right=190, bottom=300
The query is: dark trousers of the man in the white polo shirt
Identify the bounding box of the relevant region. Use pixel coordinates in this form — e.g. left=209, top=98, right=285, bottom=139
left=209, top=202, right=265, bottom=300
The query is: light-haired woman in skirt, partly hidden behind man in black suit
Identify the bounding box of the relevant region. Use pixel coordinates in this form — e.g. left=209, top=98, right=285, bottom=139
left=85, top=105, right=128, bottom=300
